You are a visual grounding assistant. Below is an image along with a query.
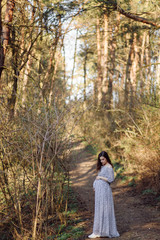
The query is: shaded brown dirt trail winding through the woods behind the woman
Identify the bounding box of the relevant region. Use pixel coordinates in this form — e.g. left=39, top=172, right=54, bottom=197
left=70, top=143, right=160, bottom=240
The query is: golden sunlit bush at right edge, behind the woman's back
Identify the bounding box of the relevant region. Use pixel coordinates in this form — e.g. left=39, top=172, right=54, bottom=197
left=117, top=107, right=160, bottom=192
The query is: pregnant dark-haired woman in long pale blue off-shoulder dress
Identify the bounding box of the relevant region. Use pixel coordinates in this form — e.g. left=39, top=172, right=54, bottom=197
left=88, top=151, right=120, bottom=238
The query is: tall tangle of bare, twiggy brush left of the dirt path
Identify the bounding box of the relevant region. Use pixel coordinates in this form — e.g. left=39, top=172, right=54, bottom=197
left=0, top=104, right=74, bottom=240
